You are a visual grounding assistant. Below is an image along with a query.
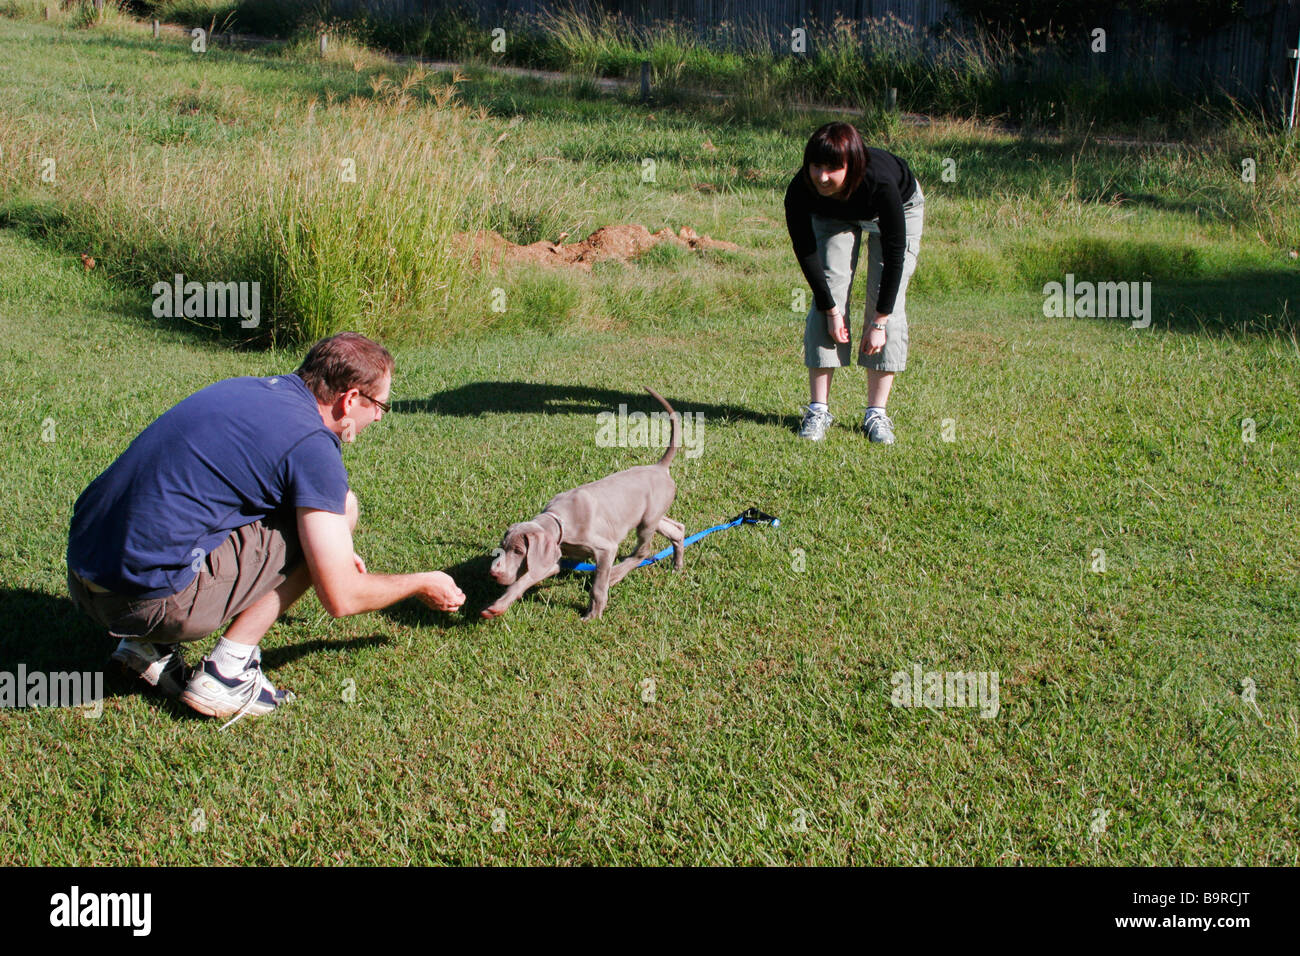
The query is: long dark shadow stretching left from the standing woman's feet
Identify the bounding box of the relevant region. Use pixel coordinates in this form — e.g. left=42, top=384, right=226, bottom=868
left=393, top=381, right=800, bottom=431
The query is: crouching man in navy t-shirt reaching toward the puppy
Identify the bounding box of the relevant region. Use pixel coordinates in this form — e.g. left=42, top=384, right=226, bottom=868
left=68, top=332, right=465, bottom=718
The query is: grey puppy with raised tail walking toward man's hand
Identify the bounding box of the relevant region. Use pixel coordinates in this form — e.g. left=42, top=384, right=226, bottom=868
left=482, top=388, right=686, bottom=620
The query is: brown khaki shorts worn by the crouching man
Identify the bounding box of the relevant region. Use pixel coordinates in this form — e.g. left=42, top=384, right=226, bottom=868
left=68, top=511, right=303, bottom=644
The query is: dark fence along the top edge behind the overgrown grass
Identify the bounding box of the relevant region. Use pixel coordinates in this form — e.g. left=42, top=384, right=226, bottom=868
left=334, top=0, right=1300, bottom=116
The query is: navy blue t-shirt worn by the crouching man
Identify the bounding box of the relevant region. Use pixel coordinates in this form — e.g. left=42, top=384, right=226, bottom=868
left=68, top=375, right=347, bottom=597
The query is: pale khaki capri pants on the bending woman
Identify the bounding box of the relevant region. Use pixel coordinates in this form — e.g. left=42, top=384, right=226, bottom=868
left=803, top=183, right=926, bottom=372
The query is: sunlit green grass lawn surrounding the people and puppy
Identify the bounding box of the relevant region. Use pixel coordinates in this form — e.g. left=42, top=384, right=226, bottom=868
left=0, top=18, right=1300, bottom=865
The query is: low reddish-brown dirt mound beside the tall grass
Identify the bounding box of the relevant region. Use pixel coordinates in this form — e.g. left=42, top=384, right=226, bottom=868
left=455, top=225, right=740, bottom=269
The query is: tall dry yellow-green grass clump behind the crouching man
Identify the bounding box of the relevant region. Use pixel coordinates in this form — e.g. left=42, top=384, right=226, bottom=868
left=0, top=70, right=491, bottom=343
